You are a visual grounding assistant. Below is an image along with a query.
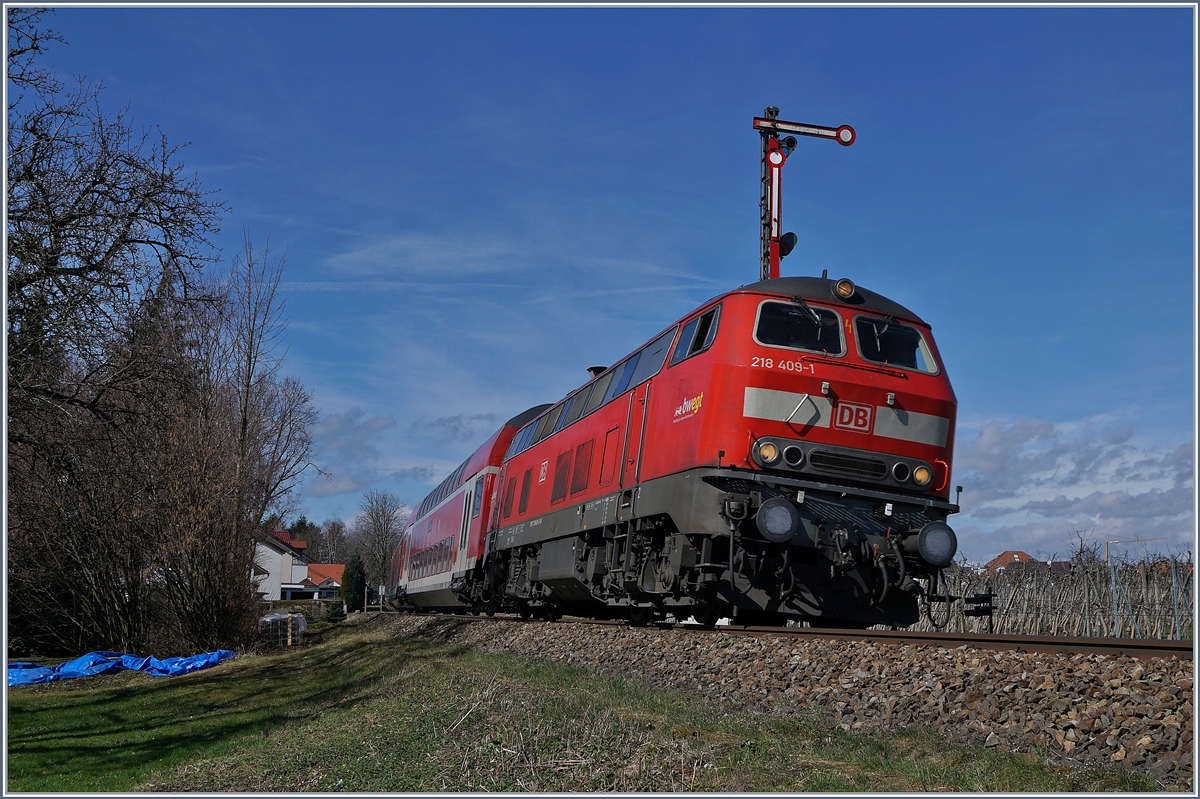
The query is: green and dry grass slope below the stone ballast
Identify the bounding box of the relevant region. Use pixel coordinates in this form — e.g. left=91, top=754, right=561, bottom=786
left=7, top=627, right=1156, bottom=793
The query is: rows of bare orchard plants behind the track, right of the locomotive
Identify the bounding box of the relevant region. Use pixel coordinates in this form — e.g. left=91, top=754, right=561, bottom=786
left=910, top=558, right=1194, bottom=641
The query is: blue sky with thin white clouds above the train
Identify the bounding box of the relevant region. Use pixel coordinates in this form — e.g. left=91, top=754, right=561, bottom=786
left=35, top=7, right=1195, bottom=560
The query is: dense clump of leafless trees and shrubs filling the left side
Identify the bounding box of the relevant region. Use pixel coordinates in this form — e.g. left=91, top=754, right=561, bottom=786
left=6, top=8, right=316, bottom=654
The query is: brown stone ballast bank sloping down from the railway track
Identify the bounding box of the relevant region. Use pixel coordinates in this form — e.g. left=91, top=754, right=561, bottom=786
left=372, top=614, right=1193, bottom=791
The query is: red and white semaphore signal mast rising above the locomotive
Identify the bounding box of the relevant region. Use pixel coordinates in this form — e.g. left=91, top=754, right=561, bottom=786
left=754, top=106, right=856, bottom=281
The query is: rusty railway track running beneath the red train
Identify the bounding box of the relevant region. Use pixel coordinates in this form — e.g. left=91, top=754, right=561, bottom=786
left=388, top=614, right=1194, bottom=660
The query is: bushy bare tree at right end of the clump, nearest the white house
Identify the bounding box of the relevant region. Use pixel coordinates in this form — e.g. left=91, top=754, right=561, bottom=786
left=152, top=234, right=316, bottom=647
